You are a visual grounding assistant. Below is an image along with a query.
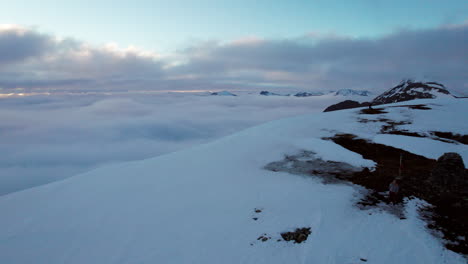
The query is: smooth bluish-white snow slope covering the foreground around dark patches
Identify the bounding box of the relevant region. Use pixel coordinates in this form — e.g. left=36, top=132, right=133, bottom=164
left=0, top=100, right=466, bottom=264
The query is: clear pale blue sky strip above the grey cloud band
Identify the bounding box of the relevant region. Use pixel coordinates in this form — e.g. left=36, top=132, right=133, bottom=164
left=0, top=0, right=468, bottom=52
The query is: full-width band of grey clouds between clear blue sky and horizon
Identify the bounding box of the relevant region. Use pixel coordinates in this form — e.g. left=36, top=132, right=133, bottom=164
left=0, top=23, right=468, bottom=93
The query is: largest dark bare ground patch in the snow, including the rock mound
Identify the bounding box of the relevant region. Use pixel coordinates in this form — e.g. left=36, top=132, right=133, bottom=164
left=328, top=134, right=468, bottom=255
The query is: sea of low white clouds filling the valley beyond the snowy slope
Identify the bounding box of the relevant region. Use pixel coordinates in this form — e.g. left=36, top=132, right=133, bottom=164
left=0, top=92, right=343, bottom=195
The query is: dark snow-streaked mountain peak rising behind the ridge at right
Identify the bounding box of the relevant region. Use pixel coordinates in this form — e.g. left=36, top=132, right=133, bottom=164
left=372, top=80, right=451, bottom=104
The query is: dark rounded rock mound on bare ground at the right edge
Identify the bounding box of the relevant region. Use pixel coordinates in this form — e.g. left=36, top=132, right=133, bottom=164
left=429, top=152, right=468, bottom=193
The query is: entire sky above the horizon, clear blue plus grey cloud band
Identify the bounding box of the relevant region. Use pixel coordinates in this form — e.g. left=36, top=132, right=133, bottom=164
left=0, top=0, right=468, bottom=94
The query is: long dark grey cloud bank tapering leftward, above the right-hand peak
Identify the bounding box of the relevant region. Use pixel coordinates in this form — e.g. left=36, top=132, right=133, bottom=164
left=172, top=24, right=468, bottom=94
